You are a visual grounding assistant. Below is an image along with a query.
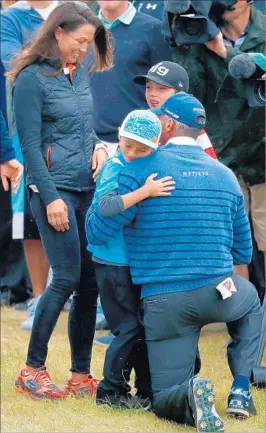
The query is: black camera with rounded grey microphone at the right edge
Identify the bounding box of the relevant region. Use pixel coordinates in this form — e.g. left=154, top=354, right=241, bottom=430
left=228, top=53, right=266, bottom=107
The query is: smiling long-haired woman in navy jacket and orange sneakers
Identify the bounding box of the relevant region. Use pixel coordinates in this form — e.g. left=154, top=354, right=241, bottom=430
left=8, top=2, right=112, bottom=399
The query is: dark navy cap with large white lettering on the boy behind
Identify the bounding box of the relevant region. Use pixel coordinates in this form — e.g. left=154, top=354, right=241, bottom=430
left=133, top=62, right=189, bottom=92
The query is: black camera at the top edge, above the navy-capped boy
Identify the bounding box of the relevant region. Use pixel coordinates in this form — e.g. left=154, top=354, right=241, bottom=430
left=163, top=0, right=236, bottom=45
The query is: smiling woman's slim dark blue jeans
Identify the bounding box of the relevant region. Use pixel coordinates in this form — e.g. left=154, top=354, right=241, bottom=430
left=26, top=190, right=98, bottom=374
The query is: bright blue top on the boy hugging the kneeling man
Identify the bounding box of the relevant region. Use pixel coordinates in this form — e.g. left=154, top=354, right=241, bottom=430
left=86, top=150, right=128, bottom=266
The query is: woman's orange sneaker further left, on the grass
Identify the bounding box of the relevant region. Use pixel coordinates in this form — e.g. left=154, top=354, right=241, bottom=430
left=15, top=367, right=65, bottom=400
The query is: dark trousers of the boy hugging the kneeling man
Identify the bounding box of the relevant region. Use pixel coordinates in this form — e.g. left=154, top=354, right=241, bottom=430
left=95, top=262, right=152, bottom=398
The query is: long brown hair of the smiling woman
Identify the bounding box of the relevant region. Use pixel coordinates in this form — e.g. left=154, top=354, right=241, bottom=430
left=6, top=1, right=113, bottom=81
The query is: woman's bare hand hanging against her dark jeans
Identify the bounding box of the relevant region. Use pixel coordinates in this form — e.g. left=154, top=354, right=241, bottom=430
left=46, top=198, right=69, bottom=232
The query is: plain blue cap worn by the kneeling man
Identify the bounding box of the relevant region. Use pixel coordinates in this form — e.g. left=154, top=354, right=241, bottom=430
left=151, top=93, right=206, bottom=129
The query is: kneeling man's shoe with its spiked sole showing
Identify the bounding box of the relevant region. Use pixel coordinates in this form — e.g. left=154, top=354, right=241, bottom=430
left=190, top=377, right=224, bottom=432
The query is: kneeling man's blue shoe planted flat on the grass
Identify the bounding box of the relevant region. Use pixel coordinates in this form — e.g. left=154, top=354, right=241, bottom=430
left=226, top=388, right=257, bottom=418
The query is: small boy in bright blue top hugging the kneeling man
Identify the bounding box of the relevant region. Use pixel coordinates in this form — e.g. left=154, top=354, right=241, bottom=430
left=86, top=110, right=174, bottom=410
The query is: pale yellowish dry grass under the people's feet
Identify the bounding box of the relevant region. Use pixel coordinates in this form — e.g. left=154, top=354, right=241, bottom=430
left=1, top=308, right=265, bottom=433
